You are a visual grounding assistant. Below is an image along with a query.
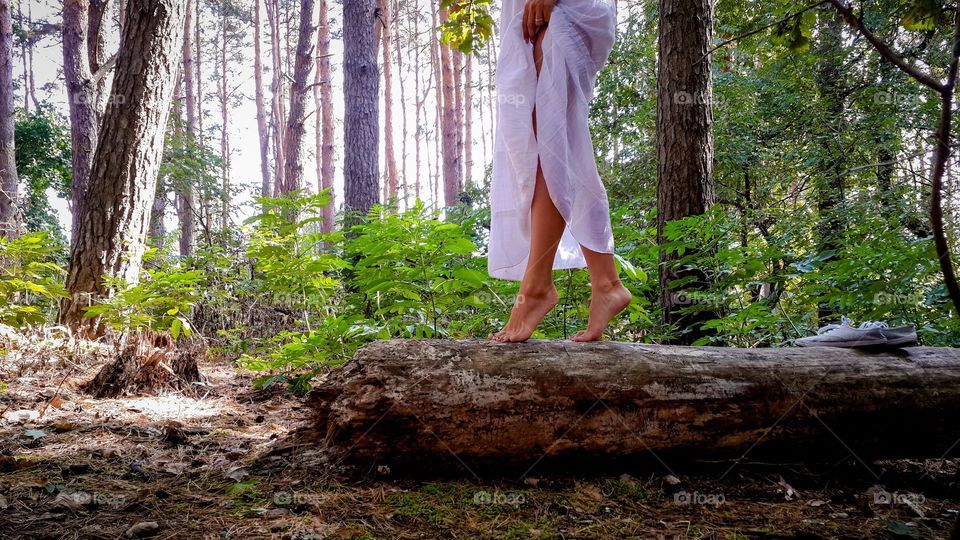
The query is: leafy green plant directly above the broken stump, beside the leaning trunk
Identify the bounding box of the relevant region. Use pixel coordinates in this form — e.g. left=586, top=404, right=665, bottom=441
left=84, top=250, right=204, bottom=339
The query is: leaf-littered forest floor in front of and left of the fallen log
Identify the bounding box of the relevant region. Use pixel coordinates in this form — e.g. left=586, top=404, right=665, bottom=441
left=0, top=330, right=960, bottom=539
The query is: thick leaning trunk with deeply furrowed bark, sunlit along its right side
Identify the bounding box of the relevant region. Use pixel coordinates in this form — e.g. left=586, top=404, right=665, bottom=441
left=61, top=0, right=185, bottom=335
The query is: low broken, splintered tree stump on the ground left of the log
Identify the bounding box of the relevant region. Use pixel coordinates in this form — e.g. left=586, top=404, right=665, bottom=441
left=83, top=331, right=206, bottom=398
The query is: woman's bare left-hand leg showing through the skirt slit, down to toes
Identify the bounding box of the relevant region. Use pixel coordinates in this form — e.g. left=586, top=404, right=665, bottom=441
left=490, top=26, right=566, bottom=342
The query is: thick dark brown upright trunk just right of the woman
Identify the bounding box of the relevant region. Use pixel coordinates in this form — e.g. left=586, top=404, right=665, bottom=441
left=657, top=0, right=714, bottom=343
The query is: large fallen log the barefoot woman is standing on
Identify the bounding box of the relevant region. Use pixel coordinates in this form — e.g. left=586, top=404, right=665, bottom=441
left=311, top=340, right=960, bottom=472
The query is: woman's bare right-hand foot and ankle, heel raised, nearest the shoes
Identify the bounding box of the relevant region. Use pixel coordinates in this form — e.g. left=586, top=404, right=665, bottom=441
left=573, top=245, right=633, bottom=341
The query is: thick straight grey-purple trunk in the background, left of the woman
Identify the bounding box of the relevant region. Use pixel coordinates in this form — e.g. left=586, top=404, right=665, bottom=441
left=343, top=0, right=380, bottom=217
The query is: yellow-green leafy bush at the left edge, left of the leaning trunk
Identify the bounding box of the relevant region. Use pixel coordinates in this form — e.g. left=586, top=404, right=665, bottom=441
left=0, top=232, right=67, bottom=328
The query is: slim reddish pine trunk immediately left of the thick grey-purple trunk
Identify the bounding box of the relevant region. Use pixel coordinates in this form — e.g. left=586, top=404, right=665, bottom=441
left=317, top=0, right=337, bottom=234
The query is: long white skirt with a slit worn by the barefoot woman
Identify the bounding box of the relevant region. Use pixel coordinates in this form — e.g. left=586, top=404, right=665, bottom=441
left=488, top=0, right=617, bottom=280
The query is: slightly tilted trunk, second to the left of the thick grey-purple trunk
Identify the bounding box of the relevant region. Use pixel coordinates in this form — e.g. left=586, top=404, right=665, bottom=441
left=283, top=0, right=317, bottom=193
